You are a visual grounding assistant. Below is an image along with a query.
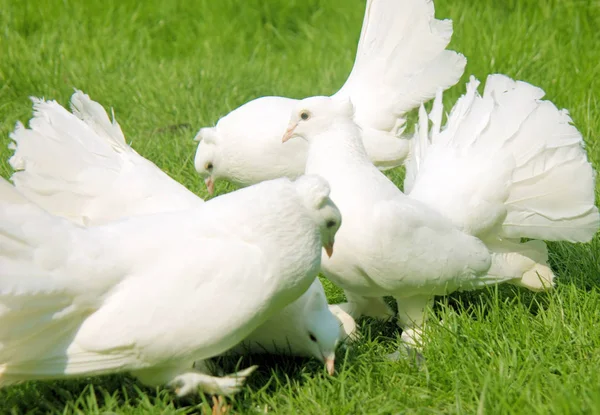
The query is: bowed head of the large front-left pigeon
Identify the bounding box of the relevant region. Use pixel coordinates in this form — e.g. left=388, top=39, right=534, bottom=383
left=295, top=175, right=342, bottom=257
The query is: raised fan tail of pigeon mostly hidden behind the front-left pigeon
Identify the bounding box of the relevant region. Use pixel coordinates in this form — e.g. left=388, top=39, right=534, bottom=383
left=10, top=91, right=202, bottom=224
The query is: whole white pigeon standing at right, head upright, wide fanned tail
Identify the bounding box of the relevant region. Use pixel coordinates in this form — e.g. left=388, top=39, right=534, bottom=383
left=283, top=75, right=600, bottom=352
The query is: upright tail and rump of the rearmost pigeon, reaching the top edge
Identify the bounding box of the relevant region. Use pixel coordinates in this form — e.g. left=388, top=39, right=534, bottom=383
left=335, top=0, right=466, bottom=168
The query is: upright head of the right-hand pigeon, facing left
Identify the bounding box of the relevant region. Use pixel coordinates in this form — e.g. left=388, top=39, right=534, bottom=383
left=282, top=97, right=354, bottom=143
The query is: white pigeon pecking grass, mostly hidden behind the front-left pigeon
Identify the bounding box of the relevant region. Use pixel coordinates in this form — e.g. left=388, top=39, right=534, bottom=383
left=10, top=91, right=356, bottom=373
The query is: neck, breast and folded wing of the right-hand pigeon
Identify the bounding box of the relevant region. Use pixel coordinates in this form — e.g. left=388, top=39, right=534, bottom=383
left=306, top=112, right=490, bottom=297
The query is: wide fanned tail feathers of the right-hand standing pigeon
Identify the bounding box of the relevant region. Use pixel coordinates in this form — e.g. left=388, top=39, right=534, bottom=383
left=406, top=75, right=600, bottom=242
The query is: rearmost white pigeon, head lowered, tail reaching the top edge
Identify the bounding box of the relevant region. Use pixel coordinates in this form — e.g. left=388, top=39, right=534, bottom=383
left=195, top=0, right=466, bottom=193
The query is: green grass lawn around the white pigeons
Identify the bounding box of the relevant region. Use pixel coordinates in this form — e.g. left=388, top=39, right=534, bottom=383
left=0, top=0, right=600, bottom=414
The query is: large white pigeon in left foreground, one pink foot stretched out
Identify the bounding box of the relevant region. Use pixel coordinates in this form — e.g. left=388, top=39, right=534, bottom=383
left=0, top=176, right=341, bottom=395
